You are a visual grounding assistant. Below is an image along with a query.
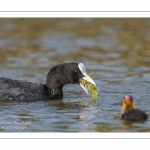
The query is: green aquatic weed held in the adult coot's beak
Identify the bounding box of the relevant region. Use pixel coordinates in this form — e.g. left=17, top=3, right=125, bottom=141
left=80, top=72, right=99, bottom=100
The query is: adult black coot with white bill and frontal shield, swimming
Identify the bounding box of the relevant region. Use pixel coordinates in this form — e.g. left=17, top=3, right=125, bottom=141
left=0, top=63, right=95, bottom=100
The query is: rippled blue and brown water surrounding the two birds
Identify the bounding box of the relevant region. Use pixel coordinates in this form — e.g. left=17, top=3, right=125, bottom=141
left=0, top=18, right=150, bottom=132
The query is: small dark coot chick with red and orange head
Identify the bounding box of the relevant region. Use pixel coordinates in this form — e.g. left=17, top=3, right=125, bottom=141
left=121, top=95, right=148, bottom=121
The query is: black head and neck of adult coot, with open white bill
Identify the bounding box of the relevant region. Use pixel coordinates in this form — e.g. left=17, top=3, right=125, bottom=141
left=46, top=63, right=96, bottom=98
